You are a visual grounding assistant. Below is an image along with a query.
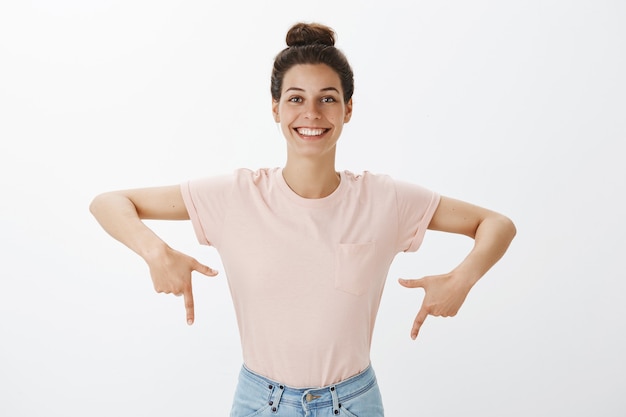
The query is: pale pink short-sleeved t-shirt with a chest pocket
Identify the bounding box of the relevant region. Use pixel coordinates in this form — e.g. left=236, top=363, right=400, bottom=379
left=181, top=168, right=439, bottom=388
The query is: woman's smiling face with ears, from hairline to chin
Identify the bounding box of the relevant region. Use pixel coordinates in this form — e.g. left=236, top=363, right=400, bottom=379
left=272, top=64, right=352, bottom=161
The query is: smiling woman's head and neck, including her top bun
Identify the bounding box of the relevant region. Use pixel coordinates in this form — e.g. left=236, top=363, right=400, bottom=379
left=270, top=23, right=354, bottom=198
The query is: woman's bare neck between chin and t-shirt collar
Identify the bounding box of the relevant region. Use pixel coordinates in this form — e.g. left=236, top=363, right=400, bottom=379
left=283, top=159, right=341, bottom=198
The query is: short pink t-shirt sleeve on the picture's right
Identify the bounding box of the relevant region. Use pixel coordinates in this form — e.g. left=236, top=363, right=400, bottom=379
left=395, top=181, right=440, bottom=252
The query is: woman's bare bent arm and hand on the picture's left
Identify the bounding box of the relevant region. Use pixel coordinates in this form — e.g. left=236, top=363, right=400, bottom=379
left=89, top=185, right=217, bottom=324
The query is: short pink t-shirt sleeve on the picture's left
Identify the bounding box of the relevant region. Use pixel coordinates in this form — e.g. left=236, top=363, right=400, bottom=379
left=180, top=175, right=234, bottom=246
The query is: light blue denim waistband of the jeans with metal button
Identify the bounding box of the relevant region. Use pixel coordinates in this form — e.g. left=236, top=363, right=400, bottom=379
left=240, top=365, right=376, bottom=412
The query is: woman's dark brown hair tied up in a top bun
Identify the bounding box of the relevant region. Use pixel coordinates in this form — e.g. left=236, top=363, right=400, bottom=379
left=270, top=23, right=354, bottom=103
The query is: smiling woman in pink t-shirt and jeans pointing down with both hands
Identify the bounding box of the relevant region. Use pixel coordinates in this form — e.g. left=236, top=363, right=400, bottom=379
left=91, top=24, right=515, bottom=417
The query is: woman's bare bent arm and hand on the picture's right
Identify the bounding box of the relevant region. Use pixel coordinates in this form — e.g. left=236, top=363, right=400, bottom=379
left=399, top=197, right=516, bottom=339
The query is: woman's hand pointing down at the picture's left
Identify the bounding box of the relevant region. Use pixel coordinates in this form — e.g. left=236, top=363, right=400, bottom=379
left=146, top=246, right=217, bottom=325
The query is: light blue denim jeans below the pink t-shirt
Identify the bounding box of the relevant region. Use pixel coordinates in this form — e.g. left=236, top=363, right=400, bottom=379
left=230, top=366, right=384, bottom=417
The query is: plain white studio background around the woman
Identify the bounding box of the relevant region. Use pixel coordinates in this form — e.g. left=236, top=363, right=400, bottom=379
left=0, top=0, right=626, bottom=417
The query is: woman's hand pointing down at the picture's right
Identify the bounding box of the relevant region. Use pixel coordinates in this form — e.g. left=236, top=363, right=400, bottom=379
left=398, top=274, right=471, bottom=340
